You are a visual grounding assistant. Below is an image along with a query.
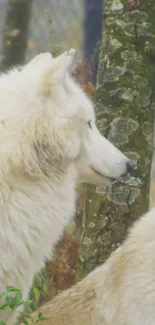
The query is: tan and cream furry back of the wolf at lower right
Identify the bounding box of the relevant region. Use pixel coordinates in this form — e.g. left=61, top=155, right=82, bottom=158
left=31, top=208, right=155, bottom=325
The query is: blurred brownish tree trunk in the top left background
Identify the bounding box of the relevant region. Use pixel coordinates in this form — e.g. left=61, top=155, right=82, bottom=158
left=0, top=0, right=33, bottom=71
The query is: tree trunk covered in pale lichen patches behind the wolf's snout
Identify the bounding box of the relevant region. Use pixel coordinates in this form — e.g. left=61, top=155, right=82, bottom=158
left=78, top=0, right=155, bottom=279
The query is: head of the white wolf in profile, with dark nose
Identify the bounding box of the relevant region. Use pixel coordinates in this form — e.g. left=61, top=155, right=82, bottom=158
left=0, top=50, right=132, bottom=184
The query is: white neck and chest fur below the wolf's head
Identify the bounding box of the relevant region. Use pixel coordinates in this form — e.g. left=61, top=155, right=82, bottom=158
left=0, top=159, right=75, bottom=324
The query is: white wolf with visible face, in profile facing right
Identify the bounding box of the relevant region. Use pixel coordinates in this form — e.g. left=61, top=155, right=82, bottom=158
left=0, top=50, right=132, bottom=324
